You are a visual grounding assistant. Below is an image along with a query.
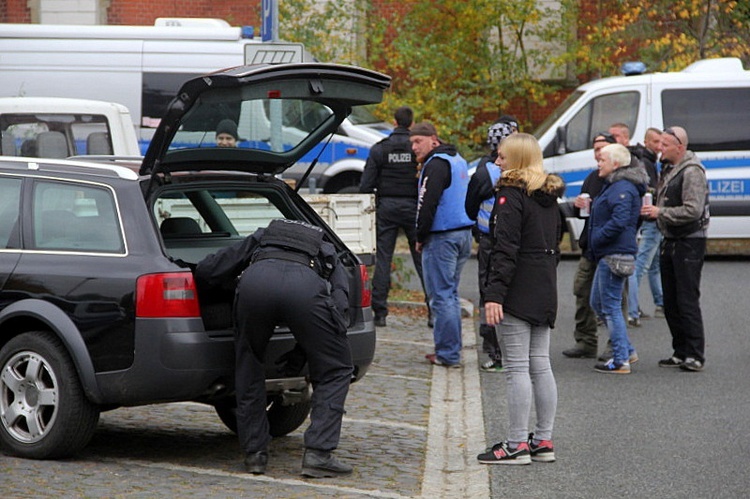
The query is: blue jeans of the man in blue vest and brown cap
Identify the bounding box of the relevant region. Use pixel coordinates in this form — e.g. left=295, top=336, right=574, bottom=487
left=422, top=229, right=471, bottom=364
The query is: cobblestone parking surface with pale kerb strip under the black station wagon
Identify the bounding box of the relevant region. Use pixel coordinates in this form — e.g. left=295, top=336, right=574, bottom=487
left=0, top=313, right=489, bottom=498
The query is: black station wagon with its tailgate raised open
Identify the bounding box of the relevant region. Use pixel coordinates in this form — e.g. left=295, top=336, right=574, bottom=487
left=0, top=63, right=390, bottom=458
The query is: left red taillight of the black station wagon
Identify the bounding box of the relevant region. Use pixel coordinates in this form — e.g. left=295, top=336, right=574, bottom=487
left=135, top=272, right=201, bottom=317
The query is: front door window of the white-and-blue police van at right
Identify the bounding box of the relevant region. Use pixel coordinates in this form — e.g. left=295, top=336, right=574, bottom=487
left=565, top=92, right=641, bottom=152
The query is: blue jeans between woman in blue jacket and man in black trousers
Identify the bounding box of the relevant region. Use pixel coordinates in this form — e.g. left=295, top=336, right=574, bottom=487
left=628, top=221, right=664, bottom=318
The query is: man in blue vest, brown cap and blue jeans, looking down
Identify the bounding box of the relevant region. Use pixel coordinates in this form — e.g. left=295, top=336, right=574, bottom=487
left=409, top=122, right=474, bottom=367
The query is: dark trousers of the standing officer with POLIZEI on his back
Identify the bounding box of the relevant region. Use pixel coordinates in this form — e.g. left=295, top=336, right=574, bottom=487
left=372, top=197, right=424, bottom=317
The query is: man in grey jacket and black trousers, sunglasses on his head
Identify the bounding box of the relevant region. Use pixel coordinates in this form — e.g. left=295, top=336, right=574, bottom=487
left=641, top=126, right=709, bottom=371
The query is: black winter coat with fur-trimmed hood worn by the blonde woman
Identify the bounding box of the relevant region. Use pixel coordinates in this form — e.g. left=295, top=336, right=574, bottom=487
left=485, top=170, right=565, bottom=327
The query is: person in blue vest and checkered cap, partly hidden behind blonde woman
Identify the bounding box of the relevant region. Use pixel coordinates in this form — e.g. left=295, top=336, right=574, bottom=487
left=464, top=116, right=518, bottom=372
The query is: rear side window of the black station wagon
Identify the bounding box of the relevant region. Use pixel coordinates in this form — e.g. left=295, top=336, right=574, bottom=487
left=31, top=181, right=125, bottom=253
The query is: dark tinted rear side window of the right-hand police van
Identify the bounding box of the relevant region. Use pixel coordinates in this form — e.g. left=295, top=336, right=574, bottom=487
left=661, top=88, right=750, bottom=151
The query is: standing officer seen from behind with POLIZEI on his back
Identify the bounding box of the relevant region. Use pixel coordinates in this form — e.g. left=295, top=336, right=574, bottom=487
left=359, top=106, right=424, bottom=327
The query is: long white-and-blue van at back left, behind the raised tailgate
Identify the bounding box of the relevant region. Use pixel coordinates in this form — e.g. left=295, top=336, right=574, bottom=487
left=0, top=19, right=384, bottom=193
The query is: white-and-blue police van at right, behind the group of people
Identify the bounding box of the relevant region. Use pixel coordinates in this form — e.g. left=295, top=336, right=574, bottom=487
left=534, top=58, right=750, bottom=240
